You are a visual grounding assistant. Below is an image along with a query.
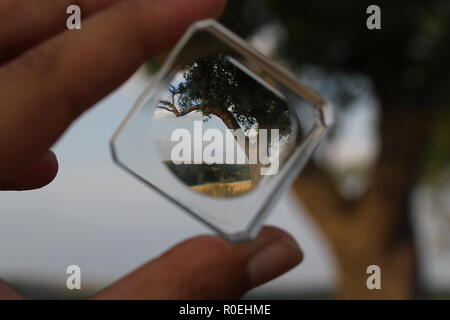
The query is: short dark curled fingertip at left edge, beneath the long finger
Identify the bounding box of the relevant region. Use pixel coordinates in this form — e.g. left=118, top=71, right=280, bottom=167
left=0, top=151, right=58, bottom=191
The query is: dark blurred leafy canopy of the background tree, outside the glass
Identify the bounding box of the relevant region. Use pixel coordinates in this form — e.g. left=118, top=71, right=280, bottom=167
left=221, top=0, right=450, bottom=181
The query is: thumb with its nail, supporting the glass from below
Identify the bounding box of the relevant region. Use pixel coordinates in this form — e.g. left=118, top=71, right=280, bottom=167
left=95, top=227, right=303, bottom=299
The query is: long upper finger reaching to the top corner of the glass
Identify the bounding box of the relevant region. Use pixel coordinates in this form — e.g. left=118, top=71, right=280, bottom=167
left=0, top=0, right=224, bottom=180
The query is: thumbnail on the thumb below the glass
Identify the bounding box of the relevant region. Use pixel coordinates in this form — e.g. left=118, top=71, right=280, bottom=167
left=248, top=235, right=303, bottom=287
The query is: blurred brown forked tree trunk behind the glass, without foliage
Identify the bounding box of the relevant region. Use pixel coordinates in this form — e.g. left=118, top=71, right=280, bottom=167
left=293, top=106, right=428, bottom=299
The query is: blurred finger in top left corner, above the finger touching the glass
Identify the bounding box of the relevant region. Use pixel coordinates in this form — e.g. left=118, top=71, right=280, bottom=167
left=0, top=0, right=122, bottom=64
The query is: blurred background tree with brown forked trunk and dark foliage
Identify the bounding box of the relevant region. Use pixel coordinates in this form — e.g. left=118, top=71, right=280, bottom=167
left=222, top=0, right=450, bottom=298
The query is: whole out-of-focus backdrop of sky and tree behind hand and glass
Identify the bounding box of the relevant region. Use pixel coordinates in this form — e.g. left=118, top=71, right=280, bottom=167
left=0, top=0, right=450, bottom=299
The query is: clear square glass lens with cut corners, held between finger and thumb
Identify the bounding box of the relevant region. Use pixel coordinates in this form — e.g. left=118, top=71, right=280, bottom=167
left=111, top=20, right=333, bottom=242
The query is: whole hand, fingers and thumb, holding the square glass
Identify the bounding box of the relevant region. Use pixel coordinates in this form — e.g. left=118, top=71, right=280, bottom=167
left=0, top=0, right=302, bottom=299
